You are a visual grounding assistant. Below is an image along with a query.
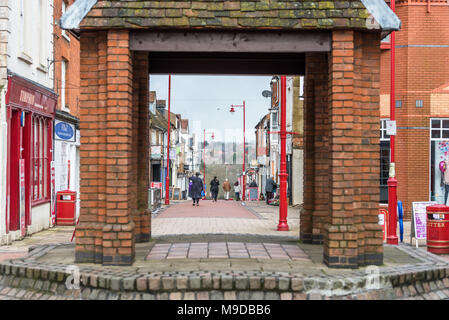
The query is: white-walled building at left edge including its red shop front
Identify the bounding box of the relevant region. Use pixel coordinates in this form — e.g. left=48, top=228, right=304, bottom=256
left=0, top=0, right=57, bottom=243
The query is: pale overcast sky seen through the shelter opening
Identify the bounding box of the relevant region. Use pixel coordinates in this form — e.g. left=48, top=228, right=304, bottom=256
left=150, top=75, right=271, bottom=142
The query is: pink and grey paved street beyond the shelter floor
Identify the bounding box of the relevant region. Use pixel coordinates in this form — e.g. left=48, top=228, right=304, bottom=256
left=151, top=200, right=300, bottom=239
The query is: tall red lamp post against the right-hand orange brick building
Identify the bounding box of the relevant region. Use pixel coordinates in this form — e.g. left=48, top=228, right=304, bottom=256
left=387, top=0, right=399, bottom=245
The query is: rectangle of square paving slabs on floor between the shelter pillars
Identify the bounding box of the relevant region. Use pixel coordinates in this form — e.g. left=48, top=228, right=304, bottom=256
left=146, top=242, right=310, bottom=261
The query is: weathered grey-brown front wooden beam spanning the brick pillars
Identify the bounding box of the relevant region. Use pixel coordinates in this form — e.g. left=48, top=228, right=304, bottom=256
left=130, top=30, right=331, bottom=53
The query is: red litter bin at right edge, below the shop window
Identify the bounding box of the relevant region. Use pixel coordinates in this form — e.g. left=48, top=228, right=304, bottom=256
left=426, top=204, right=449, bottom=254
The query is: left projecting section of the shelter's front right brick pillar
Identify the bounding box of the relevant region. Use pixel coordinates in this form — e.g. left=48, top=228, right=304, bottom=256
left=323, top=30, right=361, bottom=268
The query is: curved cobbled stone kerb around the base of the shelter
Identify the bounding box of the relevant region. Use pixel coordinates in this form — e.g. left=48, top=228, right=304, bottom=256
left=0, top=245, right=449, bottom=300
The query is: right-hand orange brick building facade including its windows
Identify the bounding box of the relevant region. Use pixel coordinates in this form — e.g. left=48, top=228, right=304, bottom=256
left=380, top=0, right=449, bottom=218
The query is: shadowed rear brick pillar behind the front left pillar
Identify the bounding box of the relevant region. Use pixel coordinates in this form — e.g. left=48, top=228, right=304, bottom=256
left=133, top=52, right=151, bottom=242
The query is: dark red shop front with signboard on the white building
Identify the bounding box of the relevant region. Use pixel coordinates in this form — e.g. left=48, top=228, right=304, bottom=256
left=6, top=75, right=57, bottom=232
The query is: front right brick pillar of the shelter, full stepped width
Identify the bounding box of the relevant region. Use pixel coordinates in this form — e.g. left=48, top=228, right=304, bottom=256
left=324, top=30, right=383, bottom=268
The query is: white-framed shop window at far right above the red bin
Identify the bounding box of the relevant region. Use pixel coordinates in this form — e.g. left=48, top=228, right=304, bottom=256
left=430, top=119, right=449, bottom=204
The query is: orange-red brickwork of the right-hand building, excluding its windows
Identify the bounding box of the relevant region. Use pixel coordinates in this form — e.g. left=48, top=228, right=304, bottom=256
left=381, top=2, right=449, bottom=219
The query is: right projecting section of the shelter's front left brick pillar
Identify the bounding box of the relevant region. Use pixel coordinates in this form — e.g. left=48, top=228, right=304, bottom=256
left=103, top=30, right=137, bottom=265
